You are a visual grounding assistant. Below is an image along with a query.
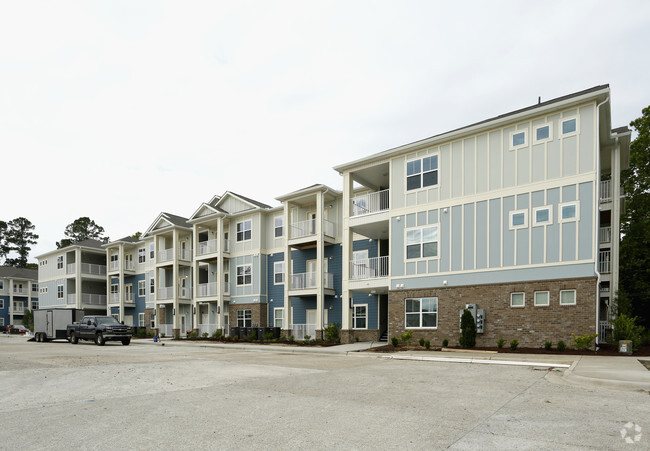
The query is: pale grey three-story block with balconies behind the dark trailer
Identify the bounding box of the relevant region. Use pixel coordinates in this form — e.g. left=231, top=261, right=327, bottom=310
left=36, top=239, right=107, bottom=314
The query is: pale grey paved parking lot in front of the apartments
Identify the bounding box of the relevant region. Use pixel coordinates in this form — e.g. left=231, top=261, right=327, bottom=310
left=0, top=336, right=650, bottom=449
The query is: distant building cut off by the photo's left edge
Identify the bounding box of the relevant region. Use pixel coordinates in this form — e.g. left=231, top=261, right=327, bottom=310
left=0, top=266, right=38, bottom=327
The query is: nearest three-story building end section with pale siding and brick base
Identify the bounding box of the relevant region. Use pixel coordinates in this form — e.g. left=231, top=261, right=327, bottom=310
left=335, top=86, right=630, bottom=346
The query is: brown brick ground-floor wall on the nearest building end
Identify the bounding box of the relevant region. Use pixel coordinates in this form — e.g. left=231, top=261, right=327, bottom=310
left=388, top=277, right=598, bottom=348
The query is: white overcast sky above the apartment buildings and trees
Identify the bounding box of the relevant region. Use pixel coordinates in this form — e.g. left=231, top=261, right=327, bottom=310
left=0, top=0, right=650, bottom=261
